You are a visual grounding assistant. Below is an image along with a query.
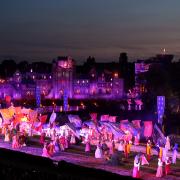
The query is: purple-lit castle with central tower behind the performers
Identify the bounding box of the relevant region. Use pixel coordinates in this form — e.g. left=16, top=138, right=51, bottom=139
left=0, top=56, right=124, bottom=99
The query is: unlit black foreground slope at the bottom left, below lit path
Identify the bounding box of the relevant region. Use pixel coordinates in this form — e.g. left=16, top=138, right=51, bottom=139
left=0, top=148, right=138, bottom=180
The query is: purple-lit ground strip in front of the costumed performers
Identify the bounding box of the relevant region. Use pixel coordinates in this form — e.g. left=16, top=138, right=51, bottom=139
left=0, top=139, right=180, bottom=180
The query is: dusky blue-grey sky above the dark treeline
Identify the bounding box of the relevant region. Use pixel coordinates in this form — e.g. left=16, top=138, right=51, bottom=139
left=0, top=0, right=180, bottom=63
